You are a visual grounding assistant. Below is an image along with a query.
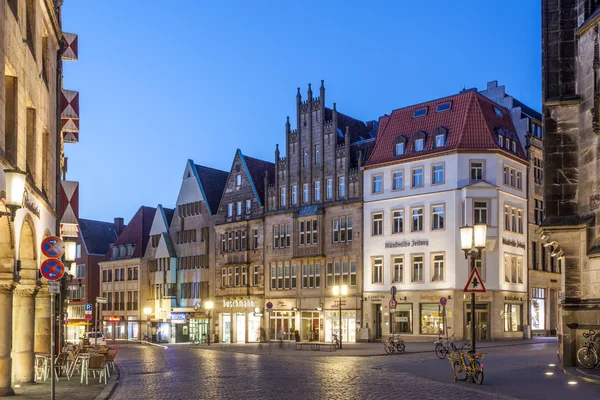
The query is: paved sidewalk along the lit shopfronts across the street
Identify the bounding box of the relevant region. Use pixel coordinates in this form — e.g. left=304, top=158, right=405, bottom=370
left=171, top=338, right=556, bottom=357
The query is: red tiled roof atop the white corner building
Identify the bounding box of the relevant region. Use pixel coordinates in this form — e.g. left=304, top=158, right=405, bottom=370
left=366, top=92, right=526, bottom=167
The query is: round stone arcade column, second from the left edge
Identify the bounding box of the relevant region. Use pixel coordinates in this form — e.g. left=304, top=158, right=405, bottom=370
left=13, top=285, right=39, bottom=383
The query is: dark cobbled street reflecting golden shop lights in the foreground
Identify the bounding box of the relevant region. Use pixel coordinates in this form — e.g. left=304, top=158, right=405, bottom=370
left=109, top=343, right=600, bottom=400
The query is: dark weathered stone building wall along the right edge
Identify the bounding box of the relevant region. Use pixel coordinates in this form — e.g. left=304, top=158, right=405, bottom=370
left=540, top=0, right=600, bottom=367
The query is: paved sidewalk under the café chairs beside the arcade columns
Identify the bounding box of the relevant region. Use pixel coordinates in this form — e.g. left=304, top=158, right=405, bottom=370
left=14, top=368, right=120, bottom=400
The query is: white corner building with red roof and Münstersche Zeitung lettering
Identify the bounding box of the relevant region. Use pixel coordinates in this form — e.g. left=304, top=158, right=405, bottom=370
left=363, top=91, right=528, bottom=340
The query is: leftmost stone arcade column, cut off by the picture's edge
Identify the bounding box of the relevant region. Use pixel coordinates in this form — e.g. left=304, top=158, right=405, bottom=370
left=0, top=281, right=15, bottom=396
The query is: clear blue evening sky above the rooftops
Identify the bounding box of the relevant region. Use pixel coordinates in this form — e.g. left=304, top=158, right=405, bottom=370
left=63, top=0, right=541, bottom=221
